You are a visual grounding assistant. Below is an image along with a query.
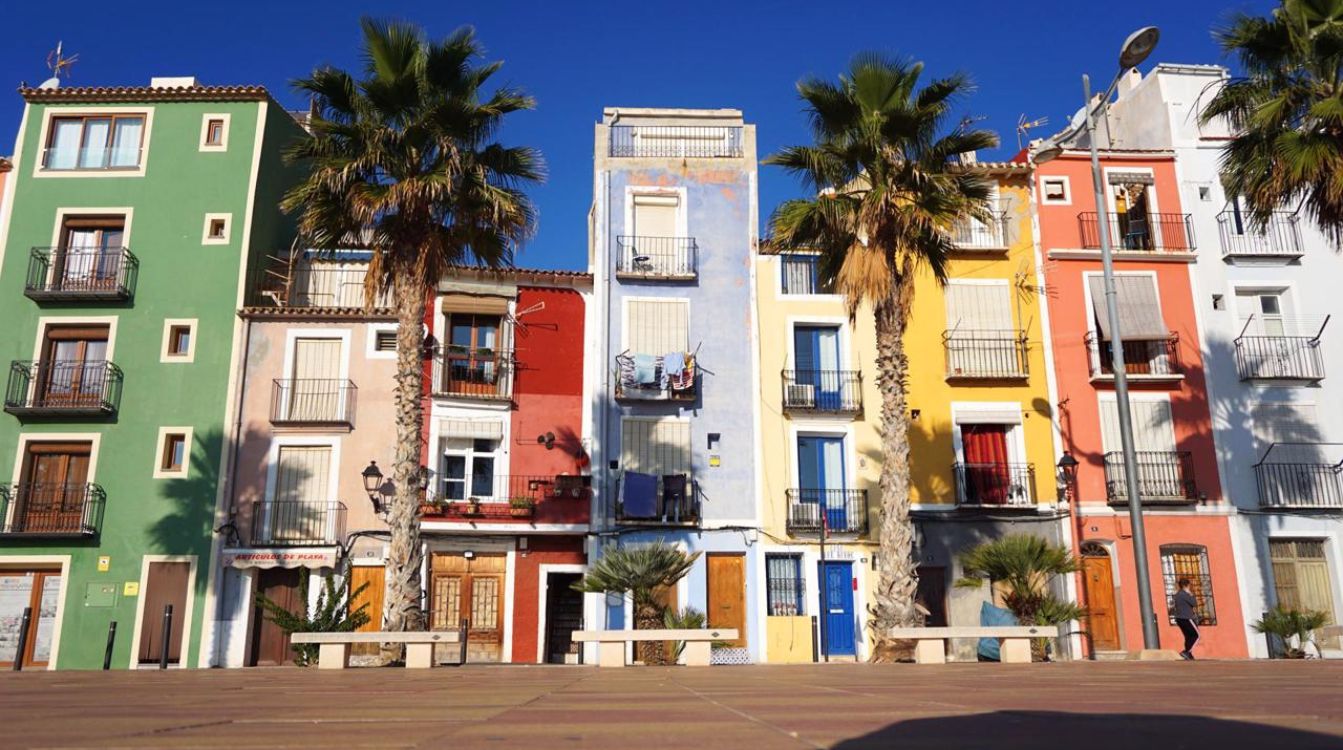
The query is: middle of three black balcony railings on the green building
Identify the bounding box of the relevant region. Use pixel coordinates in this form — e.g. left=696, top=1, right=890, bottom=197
left=4, top=359, right=122, bottom=417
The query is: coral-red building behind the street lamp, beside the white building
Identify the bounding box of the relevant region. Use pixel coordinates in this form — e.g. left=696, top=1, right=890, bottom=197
left=1035, top=151, right=1246, bottom=657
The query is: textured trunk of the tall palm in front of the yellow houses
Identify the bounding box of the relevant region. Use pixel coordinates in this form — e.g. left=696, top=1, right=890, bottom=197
left=873, top=282, right=923, bottom=661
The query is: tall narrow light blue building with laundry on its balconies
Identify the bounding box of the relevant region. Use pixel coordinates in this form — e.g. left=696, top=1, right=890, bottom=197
left=586, top=108, right=766, bottom=661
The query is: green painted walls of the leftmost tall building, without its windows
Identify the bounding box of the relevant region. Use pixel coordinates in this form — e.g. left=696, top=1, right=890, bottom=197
left=0, top=87, right=302, bottom=669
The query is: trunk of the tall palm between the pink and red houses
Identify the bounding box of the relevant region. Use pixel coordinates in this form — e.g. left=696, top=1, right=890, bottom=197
left=383, top=269, right=427, bottom=659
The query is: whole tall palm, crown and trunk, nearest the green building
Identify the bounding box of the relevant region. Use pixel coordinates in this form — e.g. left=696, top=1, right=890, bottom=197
left=282, top=19, right=544, bottom=650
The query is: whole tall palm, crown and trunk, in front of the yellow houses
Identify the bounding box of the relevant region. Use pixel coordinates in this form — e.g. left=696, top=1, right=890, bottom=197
left=766, top=54, right=998, bottom=660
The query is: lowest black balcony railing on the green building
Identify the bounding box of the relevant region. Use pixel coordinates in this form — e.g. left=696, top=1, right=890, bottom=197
left=0, top=481, right=106, bottom=538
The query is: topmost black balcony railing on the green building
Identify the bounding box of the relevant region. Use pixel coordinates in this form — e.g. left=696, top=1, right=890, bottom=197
left=23, top=247, right=140, bottom=302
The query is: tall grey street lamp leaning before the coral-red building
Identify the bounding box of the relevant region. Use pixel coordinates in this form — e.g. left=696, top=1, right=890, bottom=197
left=1034, top=26, right=1160, bottom=649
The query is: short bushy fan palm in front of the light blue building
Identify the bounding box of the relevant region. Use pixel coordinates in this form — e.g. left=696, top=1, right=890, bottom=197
left=573, top=539, right=700, bottom=664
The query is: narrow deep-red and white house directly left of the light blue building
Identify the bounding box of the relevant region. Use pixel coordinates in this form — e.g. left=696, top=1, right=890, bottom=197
left=422, top=269, right=592, bottom=663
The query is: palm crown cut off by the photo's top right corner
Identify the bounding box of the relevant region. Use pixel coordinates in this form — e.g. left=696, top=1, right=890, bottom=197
left=1202, top=0, right=1343, bottom=246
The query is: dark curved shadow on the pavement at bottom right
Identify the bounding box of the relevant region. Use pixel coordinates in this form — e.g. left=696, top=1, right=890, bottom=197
left=834, top=711, right=1343, bottom=750
